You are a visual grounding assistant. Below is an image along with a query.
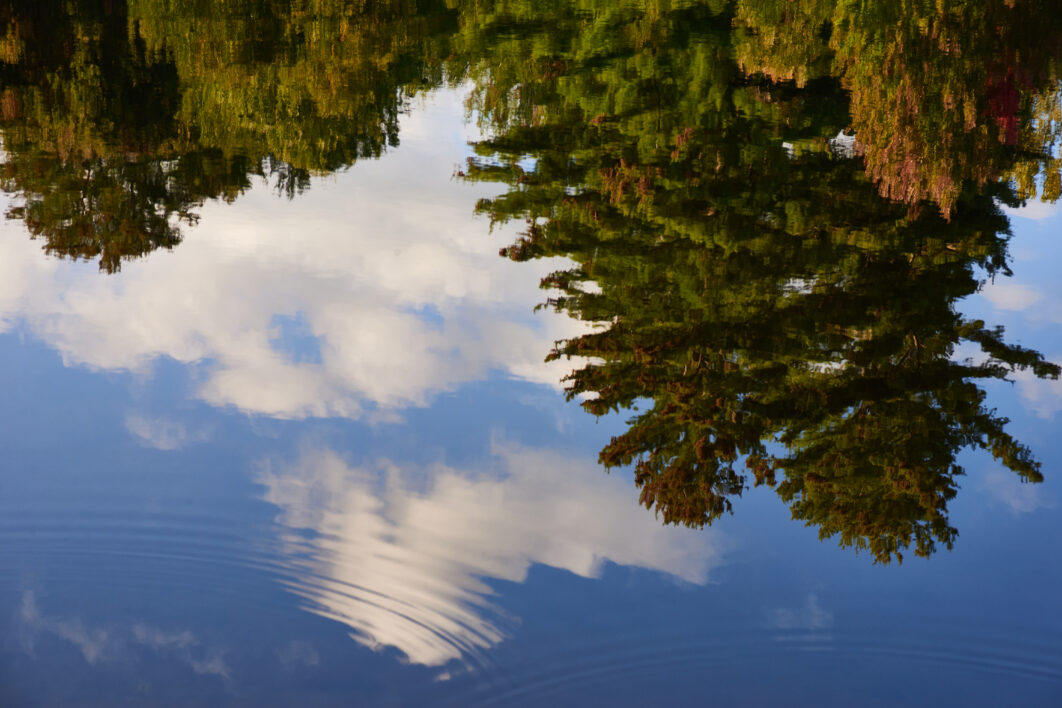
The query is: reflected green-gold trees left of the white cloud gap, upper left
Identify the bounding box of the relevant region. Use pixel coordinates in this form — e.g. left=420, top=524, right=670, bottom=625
left=0, top=0, right=452, bottom=271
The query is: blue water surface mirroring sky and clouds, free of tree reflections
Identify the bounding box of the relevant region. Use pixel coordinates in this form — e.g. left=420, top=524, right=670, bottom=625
left=0, top=91, right=1062, bottom=706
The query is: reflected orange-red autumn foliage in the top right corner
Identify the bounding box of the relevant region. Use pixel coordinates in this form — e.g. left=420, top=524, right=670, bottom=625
left=735, top=0, right=1062, bottom=215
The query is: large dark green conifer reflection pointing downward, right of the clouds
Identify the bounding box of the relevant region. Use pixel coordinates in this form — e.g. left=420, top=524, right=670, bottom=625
left=467, top=2, right=1059, bottom=562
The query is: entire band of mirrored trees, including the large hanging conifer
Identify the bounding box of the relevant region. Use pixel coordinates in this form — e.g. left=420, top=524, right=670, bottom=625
left=0, top=0, right=1062, bottom=562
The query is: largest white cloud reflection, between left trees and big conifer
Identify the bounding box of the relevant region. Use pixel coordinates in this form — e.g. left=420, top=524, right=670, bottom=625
left=0, top=92, right=579, bottom=420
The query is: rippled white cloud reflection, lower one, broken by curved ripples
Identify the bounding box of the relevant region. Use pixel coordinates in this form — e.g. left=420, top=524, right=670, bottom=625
left=260, top=444, right=719, bottom=666
